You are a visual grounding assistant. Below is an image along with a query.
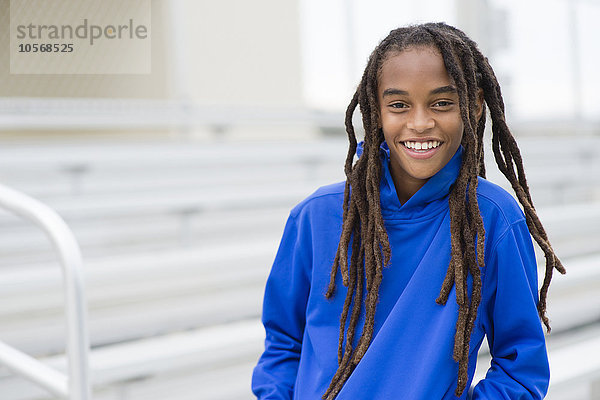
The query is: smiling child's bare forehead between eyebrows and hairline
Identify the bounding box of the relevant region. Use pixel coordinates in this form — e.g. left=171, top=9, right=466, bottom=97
left=378, top=47, right=453, bottom=92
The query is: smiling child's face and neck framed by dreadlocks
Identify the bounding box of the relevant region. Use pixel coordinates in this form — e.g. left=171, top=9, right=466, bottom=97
left=377, top=47, right=463, bottom=203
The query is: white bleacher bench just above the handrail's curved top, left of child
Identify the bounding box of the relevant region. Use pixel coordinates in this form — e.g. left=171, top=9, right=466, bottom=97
left=0, top=140, right=346, bottom=198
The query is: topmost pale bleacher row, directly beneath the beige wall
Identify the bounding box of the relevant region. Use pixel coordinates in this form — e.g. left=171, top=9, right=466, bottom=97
left=0, top=97, right=344, bottom=132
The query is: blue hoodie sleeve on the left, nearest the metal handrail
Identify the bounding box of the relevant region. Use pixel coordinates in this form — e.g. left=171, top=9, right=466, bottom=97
left=252, top=215, right=311, bottom=400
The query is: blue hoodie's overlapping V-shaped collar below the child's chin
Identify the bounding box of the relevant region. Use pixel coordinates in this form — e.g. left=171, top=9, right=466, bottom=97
left=356, top=141, right=463, bottom=220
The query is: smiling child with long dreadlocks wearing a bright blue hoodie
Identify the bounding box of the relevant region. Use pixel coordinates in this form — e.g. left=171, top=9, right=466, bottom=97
left=252, top=23, right=564, bottom=400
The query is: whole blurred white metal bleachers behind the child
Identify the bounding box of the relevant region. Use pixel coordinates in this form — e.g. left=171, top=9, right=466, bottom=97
left=0, top=137, right=600, bottom=400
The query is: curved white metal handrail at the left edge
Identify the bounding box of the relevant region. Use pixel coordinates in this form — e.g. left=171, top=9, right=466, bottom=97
left=0, top=185, right=91, bottom=400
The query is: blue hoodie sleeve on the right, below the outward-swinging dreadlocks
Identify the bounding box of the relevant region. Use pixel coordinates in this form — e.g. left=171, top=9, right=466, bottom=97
left=472, top=220, right=550, bottom=400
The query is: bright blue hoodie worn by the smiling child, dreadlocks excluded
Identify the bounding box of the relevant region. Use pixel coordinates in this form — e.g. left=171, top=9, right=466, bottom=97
left=252, top=142, right=549, bottom=400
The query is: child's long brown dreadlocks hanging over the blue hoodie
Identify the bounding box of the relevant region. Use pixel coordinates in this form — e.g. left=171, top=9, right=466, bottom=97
left=322, top=23, right=565, bottom=400
